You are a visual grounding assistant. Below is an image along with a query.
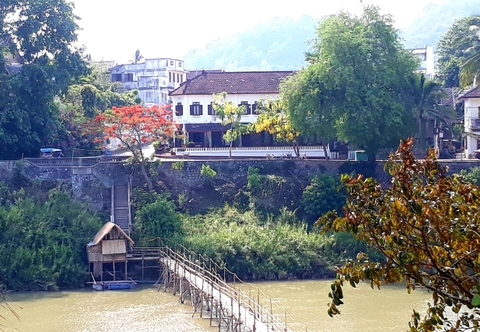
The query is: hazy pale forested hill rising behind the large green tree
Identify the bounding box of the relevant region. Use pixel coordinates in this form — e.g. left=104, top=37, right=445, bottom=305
left=184, top=0, right=480, bottom=71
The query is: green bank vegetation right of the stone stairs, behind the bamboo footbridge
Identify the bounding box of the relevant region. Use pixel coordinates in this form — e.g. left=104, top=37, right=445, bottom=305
left=133, top=167, right=379, bottom=280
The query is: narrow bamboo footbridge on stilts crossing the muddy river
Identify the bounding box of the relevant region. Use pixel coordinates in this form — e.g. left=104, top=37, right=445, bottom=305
left=157, top=246, right=307, bottom=332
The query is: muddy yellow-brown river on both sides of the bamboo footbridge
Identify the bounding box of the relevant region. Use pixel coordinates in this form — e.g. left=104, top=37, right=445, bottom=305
left=0, top=280, right=429, bottom=332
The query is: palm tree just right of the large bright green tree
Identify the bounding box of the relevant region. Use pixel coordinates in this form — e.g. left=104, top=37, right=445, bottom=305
left=410, top=74, right=453, bottom=152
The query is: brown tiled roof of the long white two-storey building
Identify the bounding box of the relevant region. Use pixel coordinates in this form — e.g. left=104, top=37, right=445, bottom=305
left=170, top=71, right=293, bottom=96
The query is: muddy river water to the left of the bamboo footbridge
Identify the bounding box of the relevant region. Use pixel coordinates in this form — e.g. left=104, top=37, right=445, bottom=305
left=0, top=286, right=214, bottom=332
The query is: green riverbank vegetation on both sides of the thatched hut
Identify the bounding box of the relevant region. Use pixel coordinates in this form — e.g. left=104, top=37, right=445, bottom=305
left=0, top=158, right=374, bottom=290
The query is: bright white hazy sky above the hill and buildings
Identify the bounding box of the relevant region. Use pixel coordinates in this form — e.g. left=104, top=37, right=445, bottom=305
left=73, top=0, right=447, bottom=63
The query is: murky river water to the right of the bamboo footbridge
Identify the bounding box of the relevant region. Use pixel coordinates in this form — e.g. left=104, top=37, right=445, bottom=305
left=238, top=280, right=431, bottom=332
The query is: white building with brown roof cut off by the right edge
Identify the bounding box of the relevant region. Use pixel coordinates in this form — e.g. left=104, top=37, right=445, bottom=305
left=460, top=86, right=480, bottom=158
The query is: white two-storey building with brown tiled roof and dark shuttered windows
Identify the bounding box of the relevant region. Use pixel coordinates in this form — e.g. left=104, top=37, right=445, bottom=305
left=170, top=70, right=293, bottom=148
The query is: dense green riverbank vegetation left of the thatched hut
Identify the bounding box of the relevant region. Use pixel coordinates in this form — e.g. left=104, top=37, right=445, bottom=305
left=0, top=183, right=102, bottom=290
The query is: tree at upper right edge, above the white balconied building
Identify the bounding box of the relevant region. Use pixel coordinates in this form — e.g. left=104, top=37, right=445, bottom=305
left=437, top=16, right=480, bottom=87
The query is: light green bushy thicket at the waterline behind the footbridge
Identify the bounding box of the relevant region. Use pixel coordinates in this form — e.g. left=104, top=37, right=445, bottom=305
left=184, top=206, right=338, bottom=280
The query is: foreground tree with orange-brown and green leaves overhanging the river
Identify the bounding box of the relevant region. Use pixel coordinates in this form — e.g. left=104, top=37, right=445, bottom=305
left=319, top=139, right=480, bottom=331
